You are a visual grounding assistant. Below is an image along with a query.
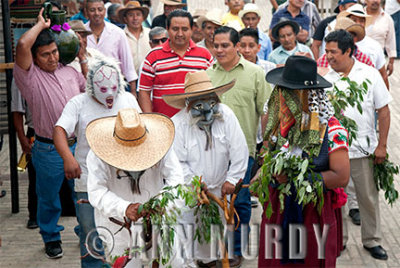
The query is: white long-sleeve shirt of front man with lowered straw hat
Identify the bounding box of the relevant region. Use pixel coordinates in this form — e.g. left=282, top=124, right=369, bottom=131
left=87, top=150, right=183, bottom=263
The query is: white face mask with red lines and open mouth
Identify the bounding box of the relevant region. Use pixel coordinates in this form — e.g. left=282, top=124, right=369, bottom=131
left=93, top=66, right=118, bottom=109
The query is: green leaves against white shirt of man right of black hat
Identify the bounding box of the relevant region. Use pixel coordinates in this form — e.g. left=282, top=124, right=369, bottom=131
left=327, top=77, right=371, bottom=145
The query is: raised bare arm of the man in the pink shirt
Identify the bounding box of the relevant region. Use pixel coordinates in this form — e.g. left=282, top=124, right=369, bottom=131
left=15, top=8, right=50, bottom=70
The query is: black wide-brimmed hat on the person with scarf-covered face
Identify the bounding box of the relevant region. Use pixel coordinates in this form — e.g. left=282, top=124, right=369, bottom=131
left=266, top=56, right=332, bottom=89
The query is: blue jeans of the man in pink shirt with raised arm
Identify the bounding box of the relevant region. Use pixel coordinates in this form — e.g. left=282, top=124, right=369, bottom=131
left=32, top=140, right=75, bottom=243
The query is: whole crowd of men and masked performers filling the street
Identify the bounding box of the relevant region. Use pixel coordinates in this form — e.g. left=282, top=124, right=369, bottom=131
left=12, top=0, right=400, bottom=267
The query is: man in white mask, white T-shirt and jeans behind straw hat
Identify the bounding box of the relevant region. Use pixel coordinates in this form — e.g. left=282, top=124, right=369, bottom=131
left=53, top=52, right=140, bottom=267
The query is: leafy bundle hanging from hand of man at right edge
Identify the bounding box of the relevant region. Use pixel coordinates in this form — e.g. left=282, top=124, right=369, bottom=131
left=370, top=155, right=399, bottom=206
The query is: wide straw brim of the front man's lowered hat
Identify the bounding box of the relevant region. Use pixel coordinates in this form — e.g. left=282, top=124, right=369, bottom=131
left=86, top=113, right=175, bottom=171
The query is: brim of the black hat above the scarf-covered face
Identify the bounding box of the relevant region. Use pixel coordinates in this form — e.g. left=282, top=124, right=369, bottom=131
left=265, top=67, right=332, bottom=89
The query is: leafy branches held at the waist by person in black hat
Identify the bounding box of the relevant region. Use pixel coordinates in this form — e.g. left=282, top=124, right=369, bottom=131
left=250, top=151, right=324, bottom=218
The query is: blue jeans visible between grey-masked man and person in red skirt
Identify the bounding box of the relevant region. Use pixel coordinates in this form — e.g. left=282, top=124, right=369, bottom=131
left=234, top=157, right=254, bottom=256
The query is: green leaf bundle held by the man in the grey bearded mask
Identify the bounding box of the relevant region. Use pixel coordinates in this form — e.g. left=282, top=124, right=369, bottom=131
left=192, top=176, right=223, bottom=244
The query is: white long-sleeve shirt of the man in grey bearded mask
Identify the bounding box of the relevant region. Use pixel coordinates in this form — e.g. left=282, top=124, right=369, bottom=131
left=172, top=103, right=249, bottom=189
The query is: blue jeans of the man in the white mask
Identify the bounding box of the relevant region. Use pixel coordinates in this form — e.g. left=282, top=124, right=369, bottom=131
left=76, top=192, right=104, bottom=268
